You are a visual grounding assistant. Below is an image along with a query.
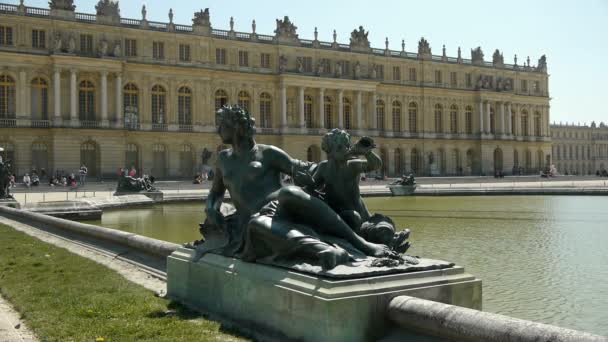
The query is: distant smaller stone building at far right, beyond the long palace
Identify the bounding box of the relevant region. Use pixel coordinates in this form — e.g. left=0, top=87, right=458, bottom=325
left=551, top=122, right=608, bottom=175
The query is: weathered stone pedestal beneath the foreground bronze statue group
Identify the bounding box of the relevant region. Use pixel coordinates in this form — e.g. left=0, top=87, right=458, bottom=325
left=167, top=248, right=481, bottom=342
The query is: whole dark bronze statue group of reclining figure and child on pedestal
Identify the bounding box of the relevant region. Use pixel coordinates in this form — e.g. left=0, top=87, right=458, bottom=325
left=195, top=106, right=426, bottom=273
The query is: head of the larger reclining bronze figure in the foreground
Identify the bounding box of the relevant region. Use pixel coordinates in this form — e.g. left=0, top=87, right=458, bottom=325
left=215, top=106, right=255, bottom=144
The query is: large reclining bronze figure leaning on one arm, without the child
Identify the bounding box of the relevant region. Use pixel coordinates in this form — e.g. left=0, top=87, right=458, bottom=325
left=202, top=106, right=401, bottom=269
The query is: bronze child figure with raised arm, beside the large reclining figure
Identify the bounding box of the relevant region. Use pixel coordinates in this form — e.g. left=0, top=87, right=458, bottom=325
left=308, top=128, right=410, bottom=253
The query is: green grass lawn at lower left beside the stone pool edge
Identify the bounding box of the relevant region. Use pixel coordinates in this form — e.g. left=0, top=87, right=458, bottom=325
left=0, top=225, right=248, bottom=341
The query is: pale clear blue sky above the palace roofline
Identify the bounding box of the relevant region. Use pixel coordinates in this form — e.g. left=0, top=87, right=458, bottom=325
left=9, top=0, right=608, bottom=123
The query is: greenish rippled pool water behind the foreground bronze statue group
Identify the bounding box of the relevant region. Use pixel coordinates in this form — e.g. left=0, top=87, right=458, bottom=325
left=91, top=196, right=608, bottom=335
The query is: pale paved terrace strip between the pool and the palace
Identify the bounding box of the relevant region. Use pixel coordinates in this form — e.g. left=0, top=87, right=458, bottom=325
left=11, top=176, right=608, bottom=206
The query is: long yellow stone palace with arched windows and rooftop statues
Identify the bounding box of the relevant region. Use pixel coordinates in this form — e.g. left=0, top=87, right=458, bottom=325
left=0, top=0, right=551, bottom=177
